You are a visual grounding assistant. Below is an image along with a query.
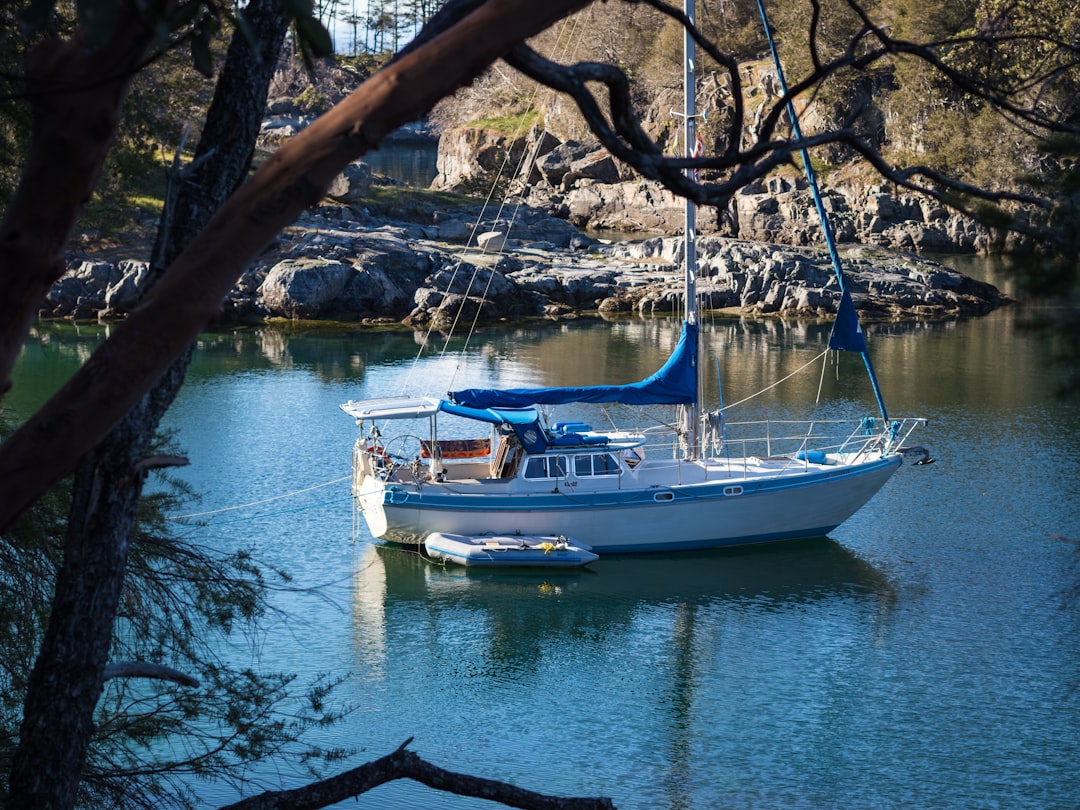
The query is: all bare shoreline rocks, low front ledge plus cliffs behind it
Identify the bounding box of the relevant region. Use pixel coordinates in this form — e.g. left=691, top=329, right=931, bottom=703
left=48, top=124, right=1010, bottom=328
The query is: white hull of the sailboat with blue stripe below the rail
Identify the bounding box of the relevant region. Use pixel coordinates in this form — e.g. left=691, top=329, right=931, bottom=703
left=357, top=454, right=901, bottom=554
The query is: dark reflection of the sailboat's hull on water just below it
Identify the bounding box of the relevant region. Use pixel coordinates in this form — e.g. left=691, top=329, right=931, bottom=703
left=354, top=538, right=894, bottom=666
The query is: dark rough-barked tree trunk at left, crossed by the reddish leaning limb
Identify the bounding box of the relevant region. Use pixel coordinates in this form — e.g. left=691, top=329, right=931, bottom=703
left=6, top=0, right=288, bottom=809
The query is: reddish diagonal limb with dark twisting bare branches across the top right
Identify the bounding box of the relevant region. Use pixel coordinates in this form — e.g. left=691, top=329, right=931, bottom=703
left=0, top=0, right=1076, bottom=527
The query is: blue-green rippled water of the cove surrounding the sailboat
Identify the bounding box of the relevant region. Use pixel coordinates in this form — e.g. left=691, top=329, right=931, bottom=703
left=5, top=295, right=1080, bottom=810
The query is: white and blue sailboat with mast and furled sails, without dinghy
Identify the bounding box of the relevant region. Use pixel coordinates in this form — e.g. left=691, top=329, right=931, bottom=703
left=341, top=2, right=924, bottom=555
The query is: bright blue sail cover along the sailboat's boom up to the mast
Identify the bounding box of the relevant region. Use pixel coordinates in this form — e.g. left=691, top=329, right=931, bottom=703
left=450, top=323, right=698, bottom=408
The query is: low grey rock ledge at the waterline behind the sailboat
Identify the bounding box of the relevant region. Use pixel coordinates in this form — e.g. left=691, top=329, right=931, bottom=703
left=50, top=192, right=1009, bottom=328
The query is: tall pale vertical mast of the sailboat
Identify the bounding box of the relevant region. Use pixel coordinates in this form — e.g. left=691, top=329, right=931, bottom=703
left=683, top=0, right=702, bottom=460
